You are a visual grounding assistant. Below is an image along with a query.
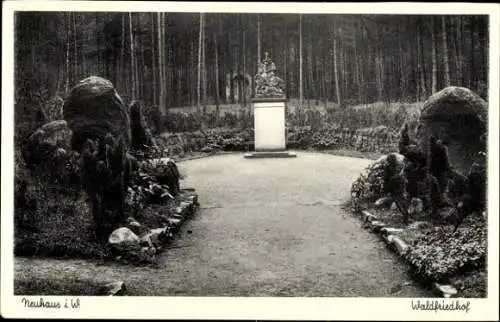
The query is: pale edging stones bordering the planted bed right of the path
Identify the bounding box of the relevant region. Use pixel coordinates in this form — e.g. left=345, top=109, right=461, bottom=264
left=361, top=210, right=458, bottom=298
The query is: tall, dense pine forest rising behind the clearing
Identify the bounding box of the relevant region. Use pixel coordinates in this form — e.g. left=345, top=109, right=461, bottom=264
left=15, top=12, right=489, bottom=124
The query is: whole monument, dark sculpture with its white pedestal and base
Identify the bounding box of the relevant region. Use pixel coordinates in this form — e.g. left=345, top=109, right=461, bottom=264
left=245, top=52, right=296, bottom=158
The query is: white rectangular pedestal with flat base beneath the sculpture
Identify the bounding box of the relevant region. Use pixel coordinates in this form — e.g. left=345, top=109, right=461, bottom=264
left=245, top=99, right=296, bottom=158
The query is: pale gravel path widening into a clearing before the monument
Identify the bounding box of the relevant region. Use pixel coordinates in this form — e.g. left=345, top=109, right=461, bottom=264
left=16, top=152, right=431, bottom=297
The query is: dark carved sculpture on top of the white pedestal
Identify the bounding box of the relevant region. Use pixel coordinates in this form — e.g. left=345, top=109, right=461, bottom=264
left=255, top=52, right=285, bottom=98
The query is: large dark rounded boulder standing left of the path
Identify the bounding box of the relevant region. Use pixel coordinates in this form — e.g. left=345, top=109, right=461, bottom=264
left=63, top=76, right=130, bottom=151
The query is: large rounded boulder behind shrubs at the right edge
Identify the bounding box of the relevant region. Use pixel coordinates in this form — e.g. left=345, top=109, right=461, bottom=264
left=416, top=87, right=488, bottom=173
